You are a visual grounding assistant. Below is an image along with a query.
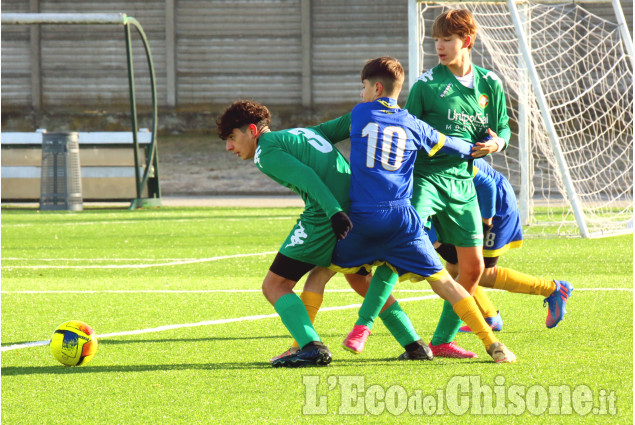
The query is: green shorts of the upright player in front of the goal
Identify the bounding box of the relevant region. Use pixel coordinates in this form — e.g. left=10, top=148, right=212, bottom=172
left=412, top=175, right=483, bottom=247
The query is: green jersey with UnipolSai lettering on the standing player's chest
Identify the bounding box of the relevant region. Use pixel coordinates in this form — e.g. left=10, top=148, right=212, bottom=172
left=405, top=64, right=511, bottom=179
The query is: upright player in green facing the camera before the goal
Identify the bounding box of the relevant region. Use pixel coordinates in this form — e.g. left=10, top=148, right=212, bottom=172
left=405, top=9, right=511, bottom=357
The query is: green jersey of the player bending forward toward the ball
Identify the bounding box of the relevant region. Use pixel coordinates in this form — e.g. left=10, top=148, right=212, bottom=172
left=254, top=116, right=351, bottom=220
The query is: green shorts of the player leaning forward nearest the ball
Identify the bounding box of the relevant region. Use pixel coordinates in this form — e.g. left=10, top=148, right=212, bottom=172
left=279, top=217, right=336, bottom=267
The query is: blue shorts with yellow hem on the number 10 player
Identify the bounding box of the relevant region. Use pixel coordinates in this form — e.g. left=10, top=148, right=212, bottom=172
left=331, top=200, right=447, bottom=281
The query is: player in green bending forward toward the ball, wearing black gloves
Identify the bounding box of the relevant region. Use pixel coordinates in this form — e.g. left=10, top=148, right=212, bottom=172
left=217, top=101, right=427, bottom=367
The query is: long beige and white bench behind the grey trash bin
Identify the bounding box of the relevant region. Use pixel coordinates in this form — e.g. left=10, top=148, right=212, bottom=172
left=1, top=129, right=151, bottom=202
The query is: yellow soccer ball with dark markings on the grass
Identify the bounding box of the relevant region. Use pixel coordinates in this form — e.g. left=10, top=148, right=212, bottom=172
left=51, top=320, right=97, bottom=366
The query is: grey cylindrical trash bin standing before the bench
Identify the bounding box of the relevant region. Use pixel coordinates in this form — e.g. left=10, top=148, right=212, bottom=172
left=40, top=133, right=83, bottom=211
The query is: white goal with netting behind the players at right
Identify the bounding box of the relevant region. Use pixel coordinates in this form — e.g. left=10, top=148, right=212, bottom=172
left=409, top=2, right=633, bottom=237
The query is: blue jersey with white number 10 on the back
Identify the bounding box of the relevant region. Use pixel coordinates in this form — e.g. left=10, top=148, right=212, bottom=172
left=350, top=97, right=472, bottom=208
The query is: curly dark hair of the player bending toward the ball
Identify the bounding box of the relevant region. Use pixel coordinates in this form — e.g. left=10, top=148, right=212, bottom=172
left=216, top=100, right=271, bottom=140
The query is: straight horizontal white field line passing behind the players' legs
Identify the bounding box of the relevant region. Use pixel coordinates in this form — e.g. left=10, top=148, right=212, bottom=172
left=0, top=288, right=633, bottom=294
